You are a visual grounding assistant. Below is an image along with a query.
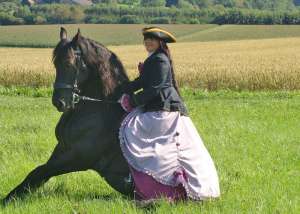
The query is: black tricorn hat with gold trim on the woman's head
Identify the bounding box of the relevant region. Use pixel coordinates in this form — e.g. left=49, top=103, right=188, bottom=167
left=142, top=27, right=176, bottom=43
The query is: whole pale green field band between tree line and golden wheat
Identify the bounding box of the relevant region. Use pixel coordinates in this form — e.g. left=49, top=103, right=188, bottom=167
left=0, top=24, right=300, bottom=48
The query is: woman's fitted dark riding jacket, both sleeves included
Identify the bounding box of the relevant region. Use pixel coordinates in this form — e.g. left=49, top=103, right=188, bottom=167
left=124, top=49, right=188, bottom=116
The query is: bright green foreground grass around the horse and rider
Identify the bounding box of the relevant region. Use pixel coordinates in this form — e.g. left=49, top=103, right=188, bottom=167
left=0, top=88, right=300, bottom=214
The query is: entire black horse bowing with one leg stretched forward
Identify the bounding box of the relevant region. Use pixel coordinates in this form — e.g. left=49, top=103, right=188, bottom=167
left=4, top=28, right=133, bottom=202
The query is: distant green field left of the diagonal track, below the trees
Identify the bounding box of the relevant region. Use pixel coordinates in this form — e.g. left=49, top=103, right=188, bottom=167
left=0, top=24, right=216, bottom=48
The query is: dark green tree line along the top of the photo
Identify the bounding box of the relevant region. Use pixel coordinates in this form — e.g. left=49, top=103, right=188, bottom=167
left=0, top=0, right=300, bottom=25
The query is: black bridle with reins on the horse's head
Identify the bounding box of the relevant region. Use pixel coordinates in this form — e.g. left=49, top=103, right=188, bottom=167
left=53, top=47, right=119, bottom=108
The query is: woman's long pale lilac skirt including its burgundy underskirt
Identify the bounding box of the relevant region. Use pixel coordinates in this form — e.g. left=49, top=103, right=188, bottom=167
left=119, top=107, right=220, bottom=200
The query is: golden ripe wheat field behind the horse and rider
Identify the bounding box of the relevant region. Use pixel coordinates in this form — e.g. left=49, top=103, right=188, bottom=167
left=0, top=38, right=300, bottom=90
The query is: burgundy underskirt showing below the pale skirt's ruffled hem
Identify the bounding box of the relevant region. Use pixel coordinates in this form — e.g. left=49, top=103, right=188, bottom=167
left=129, top=165, right=187, bottom=201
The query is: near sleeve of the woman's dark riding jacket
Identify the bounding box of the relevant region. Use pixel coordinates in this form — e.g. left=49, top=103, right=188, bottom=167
left=131, top=56, right=170, bottom=106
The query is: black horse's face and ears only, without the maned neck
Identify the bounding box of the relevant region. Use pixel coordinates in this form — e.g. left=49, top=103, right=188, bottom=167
left=52, top=28, right=90, bottom=112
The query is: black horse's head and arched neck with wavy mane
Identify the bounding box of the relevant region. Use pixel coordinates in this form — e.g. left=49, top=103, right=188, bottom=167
left=52, top=28, right=129, bottom=112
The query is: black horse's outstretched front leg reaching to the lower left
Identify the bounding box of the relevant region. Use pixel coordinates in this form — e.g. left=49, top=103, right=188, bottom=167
left=4, top=145, right=87, bottom=202
